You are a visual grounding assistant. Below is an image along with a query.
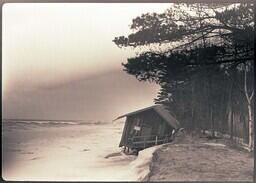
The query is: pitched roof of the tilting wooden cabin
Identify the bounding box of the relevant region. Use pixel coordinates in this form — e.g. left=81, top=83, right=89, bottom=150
left=115, top=105, right=180, bottom=129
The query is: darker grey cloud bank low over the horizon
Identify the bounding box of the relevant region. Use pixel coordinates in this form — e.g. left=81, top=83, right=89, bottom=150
left=3, top=71, right=158, bottom=121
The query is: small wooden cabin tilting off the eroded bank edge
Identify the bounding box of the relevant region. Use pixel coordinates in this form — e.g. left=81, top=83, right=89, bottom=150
left=116, top=105, right=180, bottom=152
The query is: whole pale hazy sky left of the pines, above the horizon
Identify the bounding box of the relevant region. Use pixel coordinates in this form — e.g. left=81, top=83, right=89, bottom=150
left=2, top=3, right=170, bottom=120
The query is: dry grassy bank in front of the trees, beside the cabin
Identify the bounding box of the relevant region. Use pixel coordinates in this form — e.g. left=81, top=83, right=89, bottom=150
left=150, top=135, right=253, bottom=181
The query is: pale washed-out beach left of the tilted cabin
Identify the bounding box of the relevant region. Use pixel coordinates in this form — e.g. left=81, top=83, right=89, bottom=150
left=2, top=120, right=142, bottom=181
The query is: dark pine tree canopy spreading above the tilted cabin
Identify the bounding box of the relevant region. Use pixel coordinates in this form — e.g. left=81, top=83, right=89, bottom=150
left=113, top=3, right=255, bottom=149
